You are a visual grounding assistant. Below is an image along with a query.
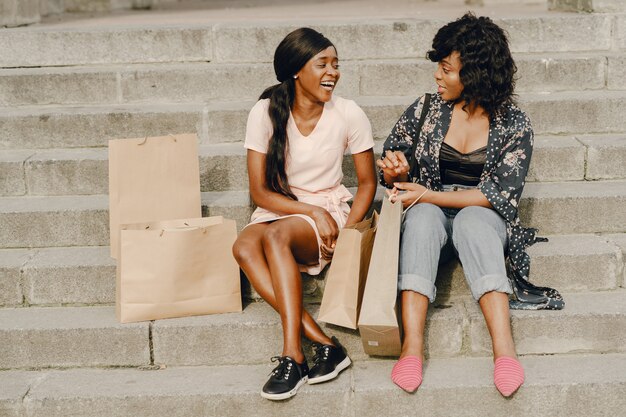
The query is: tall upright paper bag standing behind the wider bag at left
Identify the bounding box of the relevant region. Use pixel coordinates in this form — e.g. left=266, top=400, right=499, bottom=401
left=109, top=133, right=202, bottom=258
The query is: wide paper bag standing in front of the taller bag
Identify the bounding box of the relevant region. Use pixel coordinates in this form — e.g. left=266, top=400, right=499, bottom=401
left=116, top=216, right=242, bottom=323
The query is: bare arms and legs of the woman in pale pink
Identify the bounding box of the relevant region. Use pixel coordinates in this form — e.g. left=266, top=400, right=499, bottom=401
left=234, top=150, right=376, bottom=362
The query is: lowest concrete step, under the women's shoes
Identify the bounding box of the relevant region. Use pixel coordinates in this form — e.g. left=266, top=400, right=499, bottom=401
left=0, top=354, right=626, bottom=417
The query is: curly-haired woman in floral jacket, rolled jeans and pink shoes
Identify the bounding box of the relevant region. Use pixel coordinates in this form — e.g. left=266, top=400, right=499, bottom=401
left=377, top=14, right=563, bottom=396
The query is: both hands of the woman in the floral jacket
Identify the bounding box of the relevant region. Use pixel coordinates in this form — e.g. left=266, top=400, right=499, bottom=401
left=376, top=151, right=427, bottom=208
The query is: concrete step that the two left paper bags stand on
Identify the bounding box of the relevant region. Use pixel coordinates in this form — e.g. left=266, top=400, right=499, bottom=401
left=0, top=289, right=626, bottom=369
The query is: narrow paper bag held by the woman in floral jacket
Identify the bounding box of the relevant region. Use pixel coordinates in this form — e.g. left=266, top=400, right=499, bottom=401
left=359, top=198, right=402, bottom=356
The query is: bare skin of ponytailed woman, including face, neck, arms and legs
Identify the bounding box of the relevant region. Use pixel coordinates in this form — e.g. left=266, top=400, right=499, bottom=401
left=233, top=47, right=376, bottom=363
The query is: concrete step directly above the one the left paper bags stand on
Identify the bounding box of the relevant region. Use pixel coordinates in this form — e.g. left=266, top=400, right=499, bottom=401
left=0, top=234, right=626, bottom=307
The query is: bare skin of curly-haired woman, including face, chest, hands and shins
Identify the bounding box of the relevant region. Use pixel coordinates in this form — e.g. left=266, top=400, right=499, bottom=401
left=376, top=51, right=517, bottom=360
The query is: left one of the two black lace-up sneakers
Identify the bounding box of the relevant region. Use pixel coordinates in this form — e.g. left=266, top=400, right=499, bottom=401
left=261, top=356, right=309, bottom=400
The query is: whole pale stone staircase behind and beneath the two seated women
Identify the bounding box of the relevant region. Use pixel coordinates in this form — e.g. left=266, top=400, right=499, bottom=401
left=0, top=0, right=626, bottom=417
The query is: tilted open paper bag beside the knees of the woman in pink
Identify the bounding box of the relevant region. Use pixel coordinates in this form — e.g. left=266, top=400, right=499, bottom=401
left=318, top=212, right=378, bottom=329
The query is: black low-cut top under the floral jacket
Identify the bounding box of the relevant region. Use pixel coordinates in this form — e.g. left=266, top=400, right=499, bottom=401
left=439, top=142, right=487, bottom=186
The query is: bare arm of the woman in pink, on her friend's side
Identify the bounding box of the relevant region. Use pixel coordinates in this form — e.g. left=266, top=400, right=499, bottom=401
left=346, top=149, right=376, bottom=226
